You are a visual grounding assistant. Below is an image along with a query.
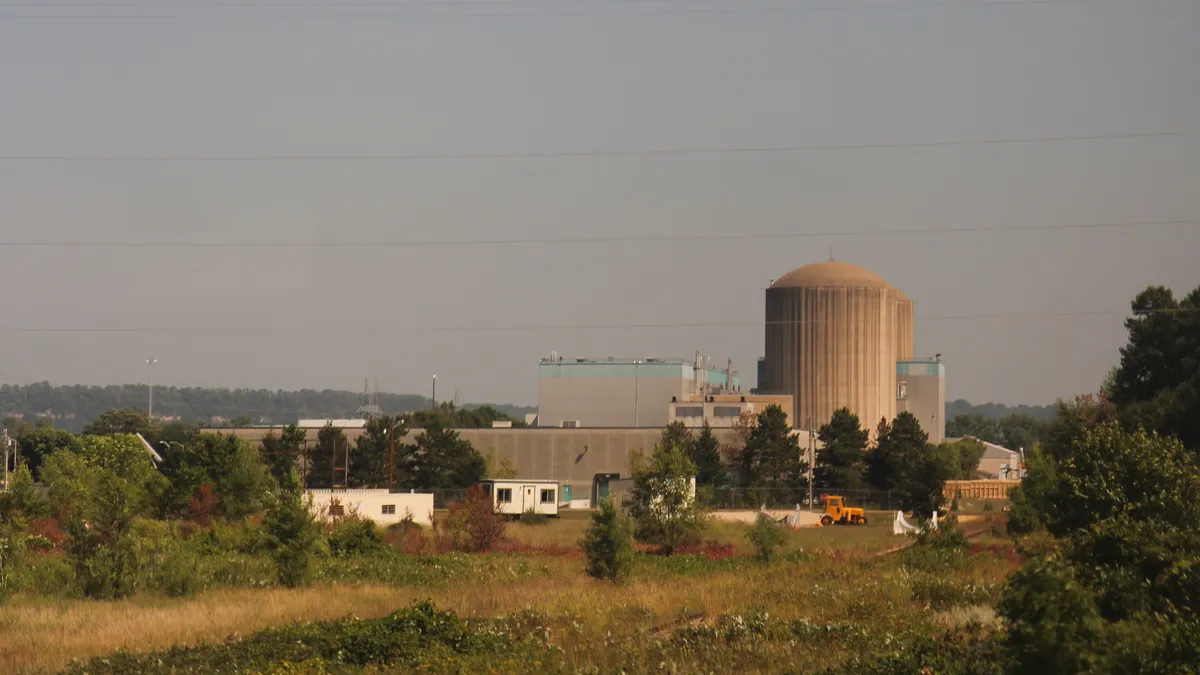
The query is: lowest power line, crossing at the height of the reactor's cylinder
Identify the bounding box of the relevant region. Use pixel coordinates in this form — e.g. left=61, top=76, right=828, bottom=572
left=0, top=307, right=1200, bottom=335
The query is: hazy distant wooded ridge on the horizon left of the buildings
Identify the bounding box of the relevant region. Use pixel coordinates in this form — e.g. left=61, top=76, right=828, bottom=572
left=0, top=382, right=536, bottom=432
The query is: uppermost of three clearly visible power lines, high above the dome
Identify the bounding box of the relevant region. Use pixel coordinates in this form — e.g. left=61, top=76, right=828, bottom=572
left=0, top=131, right=1180, bottom=162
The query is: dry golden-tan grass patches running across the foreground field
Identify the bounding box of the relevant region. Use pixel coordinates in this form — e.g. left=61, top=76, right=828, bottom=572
left=0, top=514, right=1015, bottom=673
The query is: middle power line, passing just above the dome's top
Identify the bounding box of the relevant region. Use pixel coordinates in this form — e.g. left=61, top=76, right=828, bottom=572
left=0, top=219, right=1200, bottom=249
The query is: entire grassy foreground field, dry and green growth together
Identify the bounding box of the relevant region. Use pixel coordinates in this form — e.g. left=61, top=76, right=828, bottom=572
left=0, top=513, right=1016, bottom=673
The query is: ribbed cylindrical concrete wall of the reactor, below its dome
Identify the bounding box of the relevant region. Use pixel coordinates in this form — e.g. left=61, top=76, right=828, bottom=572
left=761, top=287, right=902, bottom=430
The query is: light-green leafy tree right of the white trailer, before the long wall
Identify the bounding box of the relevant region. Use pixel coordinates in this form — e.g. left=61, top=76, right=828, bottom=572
left=629, top=446, right=707, bottom=555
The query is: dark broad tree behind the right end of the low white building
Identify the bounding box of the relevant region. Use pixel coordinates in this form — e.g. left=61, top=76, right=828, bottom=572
left=397, top=424, right=487, bottom=490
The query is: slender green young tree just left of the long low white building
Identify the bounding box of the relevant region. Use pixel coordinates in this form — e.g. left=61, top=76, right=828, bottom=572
left=263, top=471, right=320, bottom=589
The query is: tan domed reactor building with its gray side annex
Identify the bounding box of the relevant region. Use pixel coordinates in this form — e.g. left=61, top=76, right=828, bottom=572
left=756, top=261, right=946, bottom=442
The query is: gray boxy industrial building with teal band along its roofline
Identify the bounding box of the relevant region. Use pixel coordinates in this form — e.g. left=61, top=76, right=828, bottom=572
left=538, top=353, right=740, bottom=429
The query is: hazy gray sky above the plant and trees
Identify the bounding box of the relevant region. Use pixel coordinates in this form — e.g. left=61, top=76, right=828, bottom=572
left=0, top=0, right=1200, bottom=404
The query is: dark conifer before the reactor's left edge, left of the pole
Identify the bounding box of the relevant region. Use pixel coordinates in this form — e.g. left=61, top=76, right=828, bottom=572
left=740, top=406, right=808, bottom=490
